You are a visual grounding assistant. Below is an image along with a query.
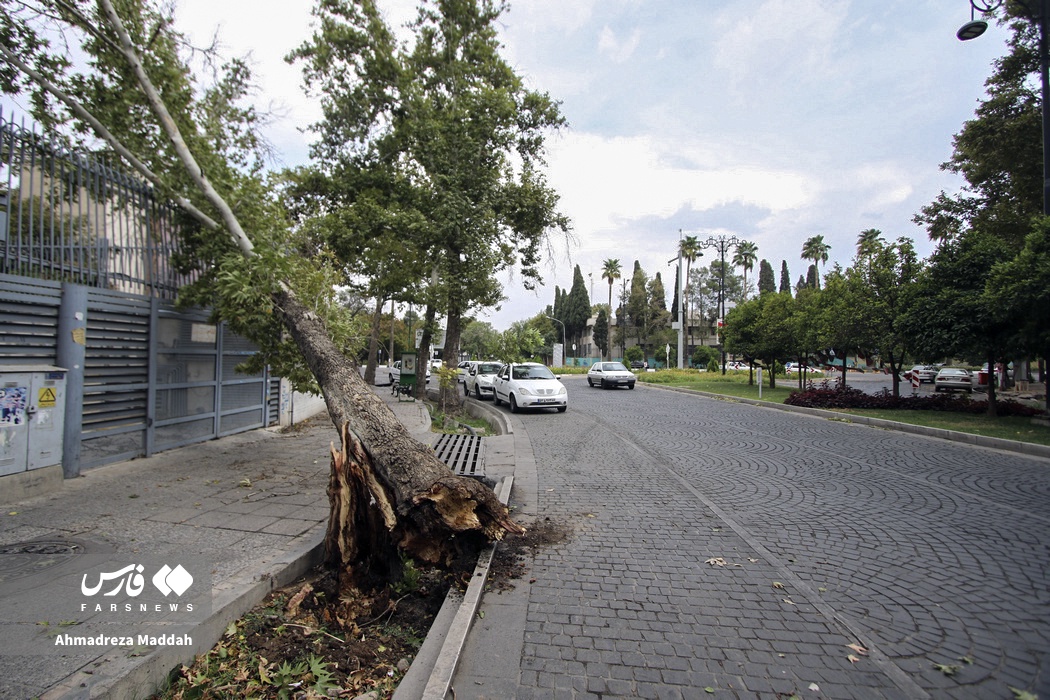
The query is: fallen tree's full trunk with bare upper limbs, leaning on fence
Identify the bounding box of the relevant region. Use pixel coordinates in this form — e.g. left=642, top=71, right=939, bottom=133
left=0, top=0, right=524, bottom=587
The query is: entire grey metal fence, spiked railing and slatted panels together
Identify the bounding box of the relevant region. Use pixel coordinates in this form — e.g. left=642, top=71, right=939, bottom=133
left=0, top=111, right=280, bottom=475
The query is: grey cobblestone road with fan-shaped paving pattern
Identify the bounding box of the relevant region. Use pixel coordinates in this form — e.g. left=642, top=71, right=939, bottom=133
left=519, top=378, right=1050, bottom=700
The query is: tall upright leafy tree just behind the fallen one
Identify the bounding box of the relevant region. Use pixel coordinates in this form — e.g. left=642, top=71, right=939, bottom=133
left=291, top=0, right=568, bottom=403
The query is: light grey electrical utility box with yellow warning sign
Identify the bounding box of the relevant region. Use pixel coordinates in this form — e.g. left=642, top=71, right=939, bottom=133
left=0, top=365, right=66, bottom=476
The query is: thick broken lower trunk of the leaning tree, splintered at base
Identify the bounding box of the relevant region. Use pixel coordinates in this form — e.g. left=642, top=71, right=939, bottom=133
left=274, top=292, right=524, bottom=584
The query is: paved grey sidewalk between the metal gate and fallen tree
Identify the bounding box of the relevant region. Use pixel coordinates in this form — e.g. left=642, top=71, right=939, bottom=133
left=0, top=387, right=432, bottom=699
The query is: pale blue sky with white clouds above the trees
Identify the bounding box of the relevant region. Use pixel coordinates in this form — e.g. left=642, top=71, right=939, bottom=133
left=170, top=0, right=1007, bottom=330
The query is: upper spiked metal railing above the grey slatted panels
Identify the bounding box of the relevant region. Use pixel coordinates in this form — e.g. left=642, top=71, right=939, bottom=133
left=0, top=110, right=195, bottom=299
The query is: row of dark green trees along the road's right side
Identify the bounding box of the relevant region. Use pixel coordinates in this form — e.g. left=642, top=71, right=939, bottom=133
left=726, top=3, right=1050, bottom=412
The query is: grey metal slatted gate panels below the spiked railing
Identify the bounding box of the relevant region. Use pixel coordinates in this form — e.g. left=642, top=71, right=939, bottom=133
left=0, top=275, right=278, bottom=469
